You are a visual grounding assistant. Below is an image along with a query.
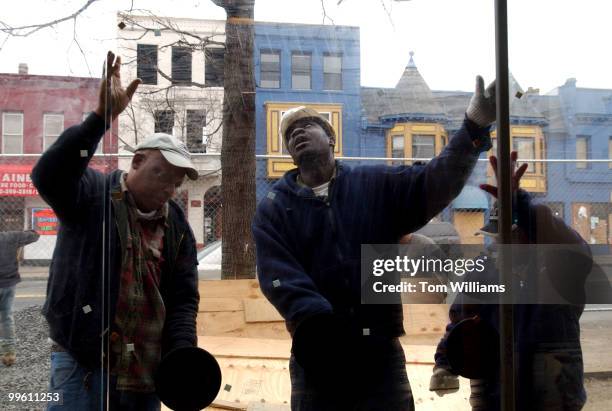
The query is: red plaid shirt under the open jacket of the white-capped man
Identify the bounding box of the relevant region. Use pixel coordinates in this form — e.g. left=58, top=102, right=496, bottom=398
left=111, top=174, right=168, bottom=392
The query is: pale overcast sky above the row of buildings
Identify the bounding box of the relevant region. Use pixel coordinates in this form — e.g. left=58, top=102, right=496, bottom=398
left=0, top=0, right=612, bottom=92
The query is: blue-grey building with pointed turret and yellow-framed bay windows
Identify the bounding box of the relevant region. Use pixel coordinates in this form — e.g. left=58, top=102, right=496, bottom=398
left=361, top=53, right=548, bottom=243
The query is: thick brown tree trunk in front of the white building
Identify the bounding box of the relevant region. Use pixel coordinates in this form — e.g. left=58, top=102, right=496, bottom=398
left=215, top=0, right=256, bottom=279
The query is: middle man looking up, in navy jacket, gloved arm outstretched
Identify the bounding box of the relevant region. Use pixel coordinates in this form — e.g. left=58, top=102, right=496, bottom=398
left=253, top=76, right=495, bottom=411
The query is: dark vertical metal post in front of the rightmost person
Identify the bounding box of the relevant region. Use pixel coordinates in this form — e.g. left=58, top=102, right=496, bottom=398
left=495, top=0, right=515, bottom=411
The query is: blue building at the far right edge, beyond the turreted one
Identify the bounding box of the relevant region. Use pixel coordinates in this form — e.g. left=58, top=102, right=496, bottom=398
left=528, top=79, right=612, bottom=244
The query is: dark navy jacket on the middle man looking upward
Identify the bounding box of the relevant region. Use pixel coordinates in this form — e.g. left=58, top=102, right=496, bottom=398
left=253, top=120, right=488, bottom=337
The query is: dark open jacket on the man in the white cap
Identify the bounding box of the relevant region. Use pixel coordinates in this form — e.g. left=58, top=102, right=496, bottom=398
left=32, top=113, right=199, bottom=368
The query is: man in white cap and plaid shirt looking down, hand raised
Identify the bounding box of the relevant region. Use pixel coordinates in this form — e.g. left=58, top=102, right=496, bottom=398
left=32, top=52, right=202, bottom=411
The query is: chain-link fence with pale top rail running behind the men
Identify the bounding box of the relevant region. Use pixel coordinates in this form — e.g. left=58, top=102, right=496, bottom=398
left=0, top=154, right=612, bottom=266
